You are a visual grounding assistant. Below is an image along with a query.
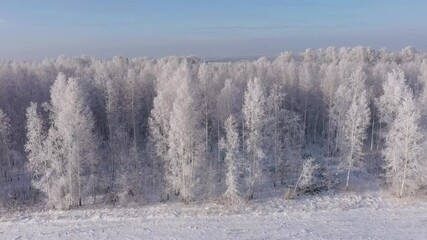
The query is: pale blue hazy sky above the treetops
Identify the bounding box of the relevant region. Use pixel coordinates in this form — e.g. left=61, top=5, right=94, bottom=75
left=0, top=0, right=427, bottom=60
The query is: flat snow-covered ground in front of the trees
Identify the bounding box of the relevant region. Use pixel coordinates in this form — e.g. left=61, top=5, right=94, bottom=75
left=0, top=192, right=427, bottom=240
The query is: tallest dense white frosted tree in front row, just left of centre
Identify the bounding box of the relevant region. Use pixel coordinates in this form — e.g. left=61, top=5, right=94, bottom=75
left=167, top=66, right=205, bottom=203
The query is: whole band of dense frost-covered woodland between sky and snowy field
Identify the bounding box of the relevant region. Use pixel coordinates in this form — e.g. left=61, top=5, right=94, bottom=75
left=0, top=47, right=427, bottom=208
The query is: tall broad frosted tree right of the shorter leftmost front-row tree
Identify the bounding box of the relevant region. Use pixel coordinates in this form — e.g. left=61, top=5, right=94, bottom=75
left=51, top=75, right=98, bottom=206
